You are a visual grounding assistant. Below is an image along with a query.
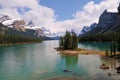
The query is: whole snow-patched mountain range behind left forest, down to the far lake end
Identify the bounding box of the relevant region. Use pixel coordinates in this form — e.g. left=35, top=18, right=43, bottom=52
left=0, top=14, right=59, bottom=40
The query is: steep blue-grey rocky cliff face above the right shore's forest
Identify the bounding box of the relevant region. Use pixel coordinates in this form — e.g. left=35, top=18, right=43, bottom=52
left=87, top=10, right=120, bottom=34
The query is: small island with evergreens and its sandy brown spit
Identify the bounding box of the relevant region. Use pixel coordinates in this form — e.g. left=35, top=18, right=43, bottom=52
left=55, top=31, right=105, bottom=56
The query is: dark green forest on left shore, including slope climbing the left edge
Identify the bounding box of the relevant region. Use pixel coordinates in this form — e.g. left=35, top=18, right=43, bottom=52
left=0, top=23, right=42, bottom=45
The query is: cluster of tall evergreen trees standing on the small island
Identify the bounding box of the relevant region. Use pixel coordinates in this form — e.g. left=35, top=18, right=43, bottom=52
left=59, top=31, right=78, bottom=50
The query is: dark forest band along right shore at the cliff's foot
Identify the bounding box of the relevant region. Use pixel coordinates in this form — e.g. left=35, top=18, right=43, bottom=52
left=79, top=32, right=120, bottom=42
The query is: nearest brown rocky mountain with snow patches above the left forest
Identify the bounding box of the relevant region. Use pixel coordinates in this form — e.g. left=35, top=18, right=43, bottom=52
left=0, top=15, right=44, bottom=37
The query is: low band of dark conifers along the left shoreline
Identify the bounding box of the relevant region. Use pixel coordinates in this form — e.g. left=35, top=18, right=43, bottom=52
left=0, top=33, right=42, bottom=44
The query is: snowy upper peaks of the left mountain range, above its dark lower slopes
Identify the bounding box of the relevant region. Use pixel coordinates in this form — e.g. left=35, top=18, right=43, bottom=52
left=0, top=15, right=57, bottom=38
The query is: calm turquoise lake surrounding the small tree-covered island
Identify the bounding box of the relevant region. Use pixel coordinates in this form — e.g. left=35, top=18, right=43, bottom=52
left=0, top=40, right=120, bottom=80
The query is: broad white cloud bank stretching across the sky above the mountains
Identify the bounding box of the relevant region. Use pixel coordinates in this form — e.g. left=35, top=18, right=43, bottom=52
left=0, top=0, right=119, bottom=32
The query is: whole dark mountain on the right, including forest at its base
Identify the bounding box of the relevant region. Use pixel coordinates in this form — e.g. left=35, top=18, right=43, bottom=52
left=79, top=5, right=120, bottom=42
